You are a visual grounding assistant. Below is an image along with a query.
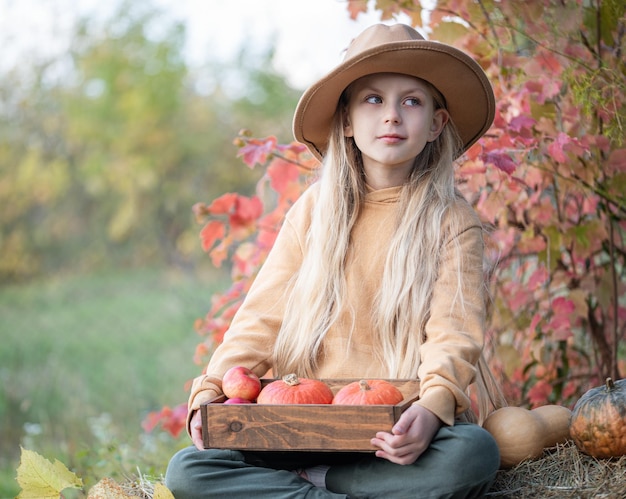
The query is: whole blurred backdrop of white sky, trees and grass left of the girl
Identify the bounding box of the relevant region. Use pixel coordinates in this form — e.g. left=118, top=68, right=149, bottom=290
left=0, top=0, right=386, bottom=497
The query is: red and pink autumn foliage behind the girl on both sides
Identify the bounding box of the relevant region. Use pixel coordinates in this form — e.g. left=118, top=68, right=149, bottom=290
left=144, top=0, right=626, bottom=438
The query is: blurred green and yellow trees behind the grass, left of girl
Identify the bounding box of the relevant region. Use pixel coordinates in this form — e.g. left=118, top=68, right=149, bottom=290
left=0, top=2, right=297, bottom=280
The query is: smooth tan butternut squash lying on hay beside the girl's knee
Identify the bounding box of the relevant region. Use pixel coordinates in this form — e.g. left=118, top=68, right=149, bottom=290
left=483, top=405, right=572, bottom=468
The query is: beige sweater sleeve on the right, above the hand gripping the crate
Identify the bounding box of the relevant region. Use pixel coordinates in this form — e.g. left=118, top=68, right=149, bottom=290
left=417, top=202, right=485, bottom=425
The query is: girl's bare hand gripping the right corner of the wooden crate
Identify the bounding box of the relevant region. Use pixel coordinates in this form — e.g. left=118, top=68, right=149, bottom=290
left=371, top=405, right=443, bottom=464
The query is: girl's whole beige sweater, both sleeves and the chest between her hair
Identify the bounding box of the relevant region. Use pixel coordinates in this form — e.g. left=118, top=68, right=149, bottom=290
left=189, top=186, right=485, bottom=425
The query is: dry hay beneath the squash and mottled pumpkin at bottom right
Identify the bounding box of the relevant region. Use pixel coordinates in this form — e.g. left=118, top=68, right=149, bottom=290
left=487, top=442, right=626, bottom=499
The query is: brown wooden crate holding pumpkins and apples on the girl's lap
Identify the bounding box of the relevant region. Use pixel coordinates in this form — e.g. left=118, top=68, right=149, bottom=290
left=200, top=379, right=419, bottom=452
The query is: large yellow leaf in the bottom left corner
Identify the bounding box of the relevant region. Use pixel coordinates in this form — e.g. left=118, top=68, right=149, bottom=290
left=16, top=448, right=83, bottom=499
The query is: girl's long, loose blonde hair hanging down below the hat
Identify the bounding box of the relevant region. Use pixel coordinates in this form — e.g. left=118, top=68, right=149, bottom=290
left=273, top=78, right=502, bottom=422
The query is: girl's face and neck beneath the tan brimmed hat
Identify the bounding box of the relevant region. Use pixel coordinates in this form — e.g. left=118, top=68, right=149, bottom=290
left=344, top=73, right=448, bottom=188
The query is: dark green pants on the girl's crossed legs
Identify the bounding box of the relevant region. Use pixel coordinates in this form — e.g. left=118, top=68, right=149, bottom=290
left=165, top=423, right=500, bottom=499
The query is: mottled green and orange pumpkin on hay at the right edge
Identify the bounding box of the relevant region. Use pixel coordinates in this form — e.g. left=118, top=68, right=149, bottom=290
left=570, top=378, right=626, bottom=458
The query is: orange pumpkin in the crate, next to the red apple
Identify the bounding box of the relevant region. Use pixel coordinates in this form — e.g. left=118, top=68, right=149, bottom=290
left=257, top=374, right=333, bottom=404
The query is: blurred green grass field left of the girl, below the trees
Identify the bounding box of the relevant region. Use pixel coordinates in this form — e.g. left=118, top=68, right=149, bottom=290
left=0, top=269, right=225, bottom=498
